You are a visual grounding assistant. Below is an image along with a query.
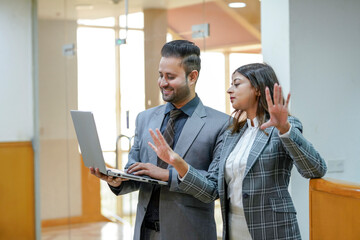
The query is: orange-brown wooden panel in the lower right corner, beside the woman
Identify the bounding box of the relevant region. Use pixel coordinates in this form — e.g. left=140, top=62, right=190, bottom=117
left=309, top=179, right=360, bottom=240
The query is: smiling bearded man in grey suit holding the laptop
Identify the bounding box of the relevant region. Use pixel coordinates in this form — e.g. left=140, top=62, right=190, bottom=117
left=90, top=40, right=229, bottom=240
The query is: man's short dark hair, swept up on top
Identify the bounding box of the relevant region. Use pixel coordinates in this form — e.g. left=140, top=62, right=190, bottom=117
left=161, top=40, right=201, bottom=77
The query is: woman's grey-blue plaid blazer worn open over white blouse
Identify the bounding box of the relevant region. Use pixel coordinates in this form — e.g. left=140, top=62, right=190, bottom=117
left=179, top=117, right=327, bottom=240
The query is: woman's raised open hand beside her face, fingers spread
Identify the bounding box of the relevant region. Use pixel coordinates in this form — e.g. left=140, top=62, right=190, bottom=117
left=260, top=83, right=290, bottom=134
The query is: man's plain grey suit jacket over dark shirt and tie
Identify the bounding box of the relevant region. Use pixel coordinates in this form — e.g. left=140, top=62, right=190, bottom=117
left=111, top=101, right=229, bottom=240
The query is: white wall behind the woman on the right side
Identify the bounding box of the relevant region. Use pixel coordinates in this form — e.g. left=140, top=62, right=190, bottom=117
left=262, top=0, right=360, bottom=239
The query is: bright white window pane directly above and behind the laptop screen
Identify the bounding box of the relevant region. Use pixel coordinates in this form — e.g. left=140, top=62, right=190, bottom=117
left=77, top=27, right=116, bottom=152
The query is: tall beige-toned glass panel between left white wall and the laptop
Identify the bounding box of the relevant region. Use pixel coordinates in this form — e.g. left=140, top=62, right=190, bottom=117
left=37, top=0, right=83, bottom=239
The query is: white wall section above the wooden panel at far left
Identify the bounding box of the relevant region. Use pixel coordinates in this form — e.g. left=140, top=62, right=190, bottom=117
left=0, top=0, right=34, bottom=142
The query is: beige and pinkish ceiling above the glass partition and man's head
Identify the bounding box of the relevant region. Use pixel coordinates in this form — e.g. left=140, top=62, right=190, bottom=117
left=38, top=0, right=261, bottom=53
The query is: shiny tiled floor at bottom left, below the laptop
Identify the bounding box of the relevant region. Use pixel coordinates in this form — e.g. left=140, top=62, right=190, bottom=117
left=41, top=222, right=133, bottom=240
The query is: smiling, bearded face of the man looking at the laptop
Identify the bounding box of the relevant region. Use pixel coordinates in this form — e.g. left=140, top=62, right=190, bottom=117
left=158, top=57, right=192, bottom=108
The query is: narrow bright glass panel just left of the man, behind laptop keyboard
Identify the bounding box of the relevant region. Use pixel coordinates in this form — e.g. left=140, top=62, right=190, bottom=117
left=119, top=30, right=145, bottom=225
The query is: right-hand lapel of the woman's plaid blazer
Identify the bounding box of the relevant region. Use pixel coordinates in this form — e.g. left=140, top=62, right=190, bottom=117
left=244, top=127, right=274, bottom=176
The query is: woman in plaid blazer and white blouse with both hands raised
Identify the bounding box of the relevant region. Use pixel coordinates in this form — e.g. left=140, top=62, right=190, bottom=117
left=149, top=63, right=326, bottom=240
